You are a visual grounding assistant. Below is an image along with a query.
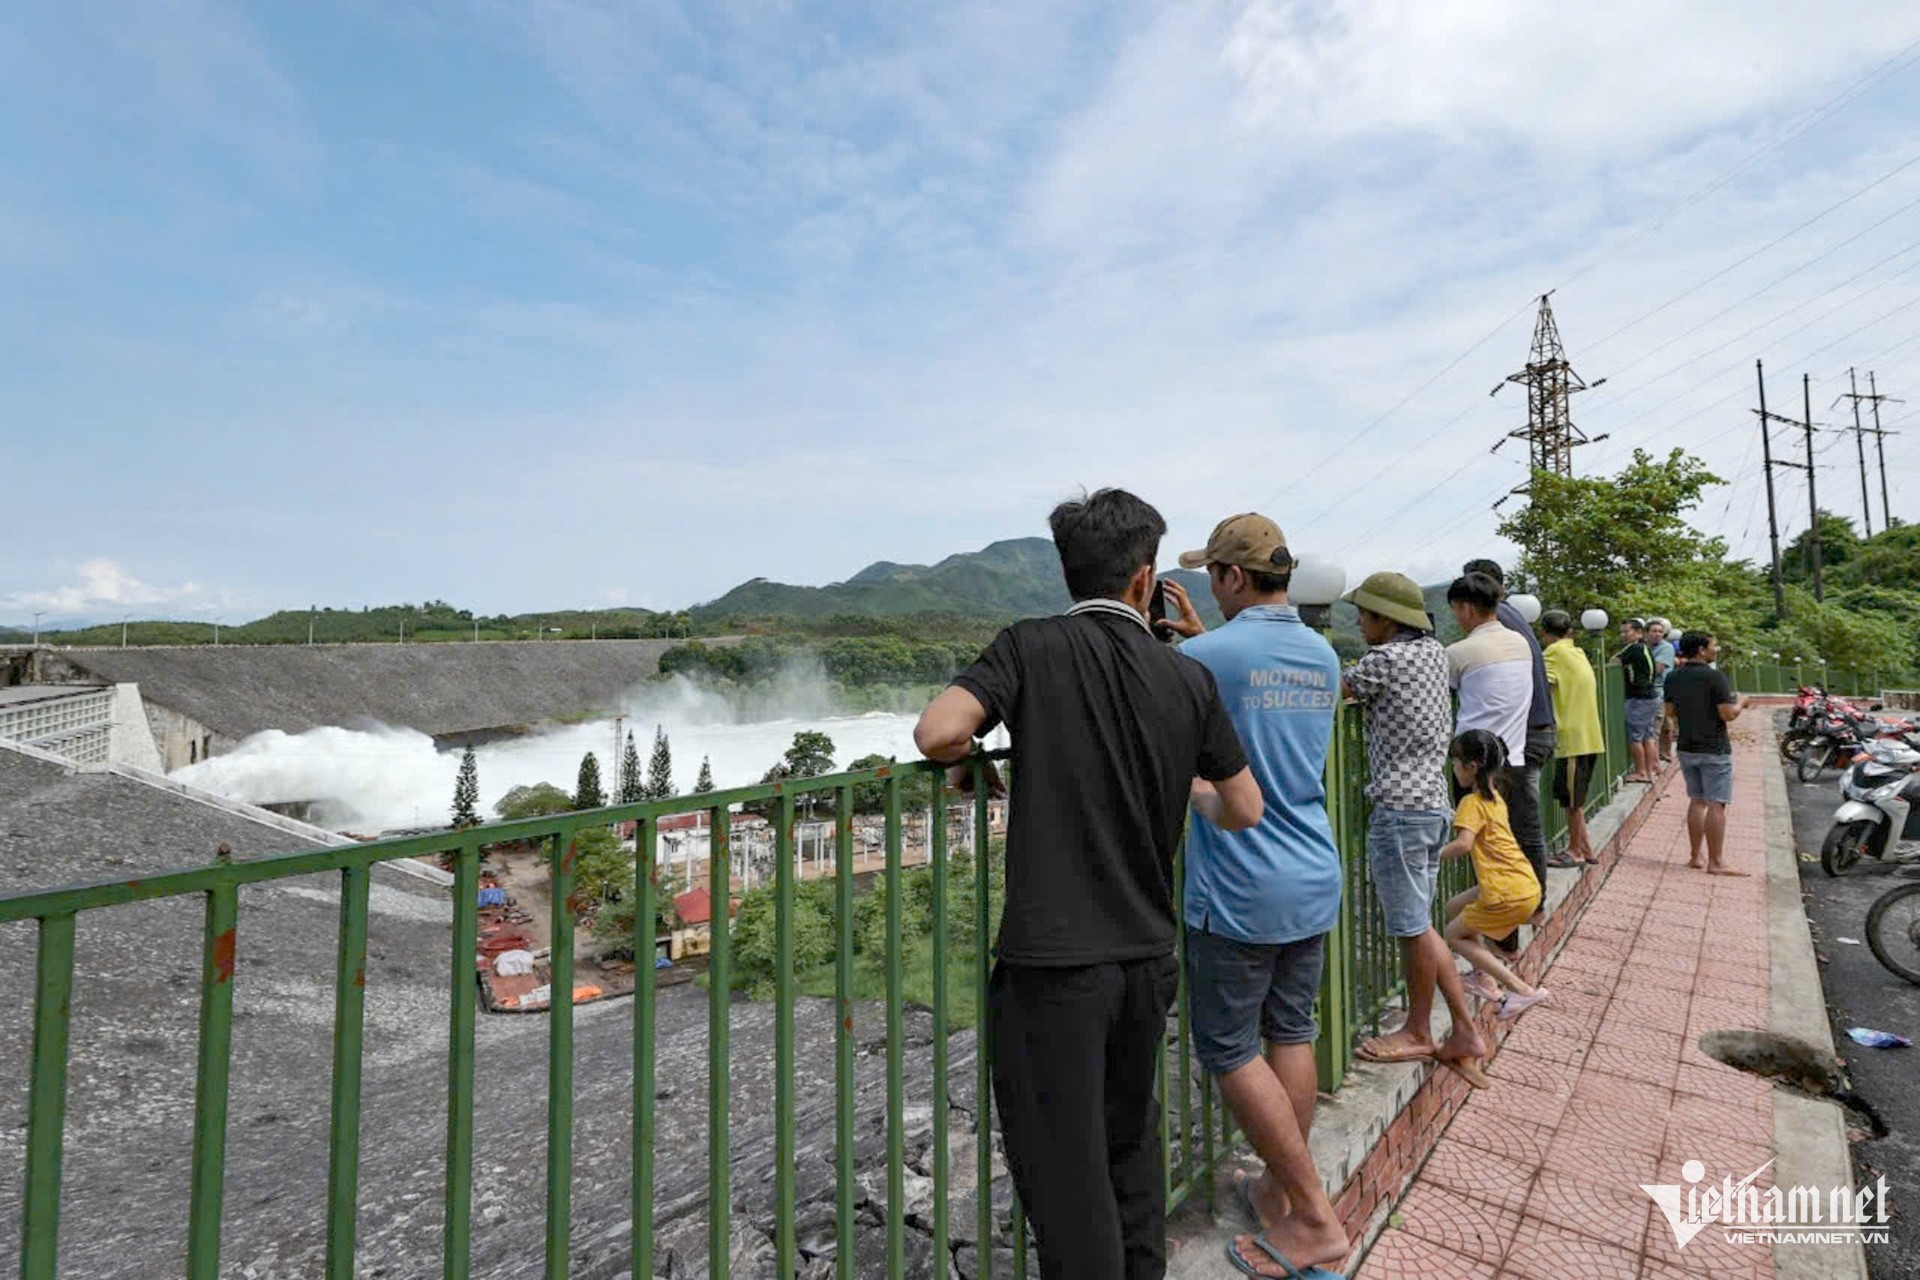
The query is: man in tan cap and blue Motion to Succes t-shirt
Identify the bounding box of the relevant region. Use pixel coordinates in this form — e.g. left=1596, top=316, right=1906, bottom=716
left=1165, top=514, right=1340, bottom=1267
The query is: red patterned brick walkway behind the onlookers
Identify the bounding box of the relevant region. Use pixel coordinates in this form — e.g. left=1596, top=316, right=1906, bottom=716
left=1357, top=723, right=1778, bottom=1280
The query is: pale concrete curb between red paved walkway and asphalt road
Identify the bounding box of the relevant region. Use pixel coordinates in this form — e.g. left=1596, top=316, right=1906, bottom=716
left=1763, top=725, right=1866, bottom=1280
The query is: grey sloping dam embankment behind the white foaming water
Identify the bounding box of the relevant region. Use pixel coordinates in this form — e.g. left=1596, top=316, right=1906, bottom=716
left=48, top=639, right=726, bottom=741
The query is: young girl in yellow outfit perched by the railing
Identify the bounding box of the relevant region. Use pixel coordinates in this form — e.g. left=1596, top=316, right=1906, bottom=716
left=1440, top=729, right=1551, bottom=1021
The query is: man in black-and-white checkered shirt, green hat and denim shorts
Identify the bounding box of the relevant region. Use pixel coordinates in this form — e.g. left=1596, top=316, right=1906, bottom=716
left=1344, top=574, right=1486, bottom=1088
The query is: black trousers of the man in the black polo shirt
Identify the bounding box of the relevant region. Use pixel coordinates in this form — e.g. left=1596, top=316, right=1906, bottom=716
left=987, top=956, right=1179, bottom=1280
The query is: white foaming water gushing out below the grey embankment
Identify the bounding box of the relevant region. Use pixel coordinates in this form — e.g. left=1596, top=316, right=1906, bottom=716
left=175, top=681, right=918, bottom=833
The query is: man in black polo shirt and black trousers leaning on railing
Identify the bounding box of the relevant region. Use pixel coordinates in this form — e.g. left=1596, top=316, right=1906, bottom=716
left=914, top=489, right=1261, bottom=1280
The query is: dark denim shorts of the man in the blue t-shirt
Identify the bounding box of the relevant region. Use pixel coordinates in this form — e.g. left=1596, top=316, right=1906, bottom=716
left=1187, top=929, right=1327, bottom=1077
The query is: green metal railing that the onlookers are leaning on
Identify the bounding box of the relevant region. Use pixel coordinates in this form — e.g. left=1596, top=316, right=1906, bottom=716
left=0, top=670, right=1626, bottom=1280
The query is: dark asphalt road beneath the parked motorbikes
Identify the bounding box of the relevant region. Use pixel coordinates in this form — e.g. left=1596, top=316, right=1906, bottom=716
left=1788, top=736, right=1920, bottom=1280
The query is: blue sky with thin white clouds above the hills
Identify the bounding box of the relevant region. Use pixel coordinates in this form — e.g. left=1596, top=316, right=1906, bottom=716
left=0, top=0, right=1920, bottom=622
